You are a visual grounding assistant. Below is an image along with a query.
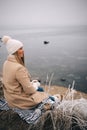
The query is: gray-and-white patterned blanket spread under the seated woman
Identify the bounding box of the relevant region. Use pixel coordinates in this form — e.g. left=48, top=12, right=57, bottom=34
left=0, top=98, right=55, bottom=124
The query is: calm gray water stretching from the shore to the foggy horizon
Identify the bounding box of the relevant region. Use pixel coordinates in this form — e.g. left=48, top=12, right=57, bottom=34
left=0, top=26, right=87, bottom=93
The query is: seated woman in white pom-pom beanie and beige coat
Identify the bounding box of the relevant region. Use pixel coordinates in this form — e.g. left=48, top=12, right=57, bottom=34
left=2, top=36, right=48, bottom=109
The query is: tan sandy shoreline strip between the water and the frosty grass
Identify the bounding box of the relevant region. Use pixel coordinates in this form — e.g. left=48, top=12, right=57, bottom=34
left=0, top=75, right=87, bottom=99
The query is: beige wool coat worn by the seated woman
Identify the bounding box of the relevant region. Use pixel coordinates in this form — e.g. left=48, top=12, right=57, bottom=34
left=3, top=55, right=48, bottom=109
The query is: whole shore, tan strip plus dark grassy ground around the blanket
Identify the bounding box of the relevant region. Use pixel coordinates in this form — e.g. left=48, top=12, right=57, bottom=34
left=0, top=76, right=87, bottom=130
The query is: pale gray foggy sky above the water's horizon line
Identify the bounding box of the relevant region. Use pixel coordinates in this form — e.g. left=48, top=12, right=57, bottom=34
left=0, top=0, right=87, bottom=26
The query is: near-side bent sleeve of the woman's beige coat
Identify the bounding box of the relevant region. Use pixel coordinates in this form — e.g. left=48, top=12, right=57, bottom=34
left=16, top=66, right=36, bottom=94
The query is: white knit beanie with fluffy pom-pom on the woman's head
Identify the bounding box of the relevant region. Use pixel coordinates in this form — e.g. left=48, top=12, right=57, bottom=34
left=2, top=36, right=23, bottom=54
